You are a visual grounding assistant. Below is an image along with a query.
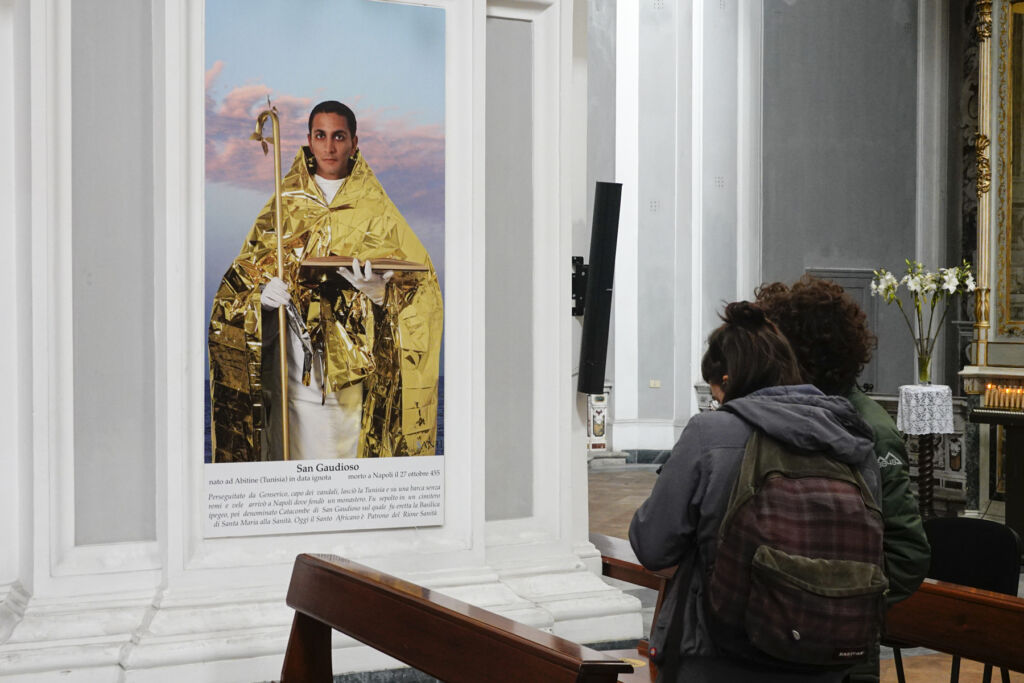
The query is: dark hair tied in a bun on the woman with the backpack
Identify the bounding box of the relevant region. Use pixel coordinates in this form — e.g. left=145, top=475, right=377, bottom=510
left=700, top=301, right=801, bottom=403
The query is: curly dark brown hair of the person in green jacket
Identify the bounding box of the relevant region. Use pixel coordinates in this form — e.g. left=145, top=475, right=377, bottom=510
left=756, top=275, right=878, bottom=395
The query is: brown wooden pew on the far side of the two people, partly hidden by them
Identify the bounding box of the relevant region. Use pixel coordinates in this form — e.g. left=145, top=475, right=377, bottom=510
left=590, top=533, right=1024, bottom=672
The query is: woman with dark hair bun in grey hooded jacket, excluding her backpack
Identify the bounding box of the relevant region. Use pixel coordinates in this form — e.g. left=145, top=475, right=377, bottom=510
left=630, top=301, right=880, bottom=683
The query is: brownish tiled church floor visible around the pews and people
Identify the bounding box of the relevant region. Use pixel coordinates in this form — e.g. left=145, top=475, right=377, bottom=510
left=589, top=463, right=1024, bottom=683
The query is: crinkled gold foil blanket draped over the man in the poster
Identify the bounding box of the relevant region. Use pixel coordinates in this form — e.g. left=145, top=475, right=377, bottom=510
left=209, top=147, right=443, bottom=463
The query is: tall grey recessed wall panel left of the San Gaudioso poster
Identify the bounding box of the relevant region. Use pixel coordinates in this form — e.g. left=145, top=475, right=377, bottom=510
left=71, top=0, right=156, bottom=545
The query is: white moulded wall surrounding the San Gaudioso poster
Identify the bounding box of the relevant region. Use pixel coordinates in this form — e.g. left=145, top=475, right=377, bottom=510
left=0, top=0, right=640, bottom=682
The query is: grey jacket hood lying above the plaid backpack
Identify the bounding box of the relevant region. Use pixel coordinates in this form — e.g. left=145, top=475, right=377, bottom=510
left=722, top=384, right=874, bottom=468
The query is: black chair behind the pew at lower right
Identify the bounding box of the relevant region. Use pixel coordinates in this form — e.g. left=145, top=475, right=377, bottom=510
left=893, top=517, right=1021, bottom=683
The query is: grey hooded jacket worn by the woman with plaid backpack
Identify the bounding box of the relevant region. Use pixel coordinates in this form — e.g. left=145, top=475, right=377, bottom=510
left=630, top=385, right=881, bottom=682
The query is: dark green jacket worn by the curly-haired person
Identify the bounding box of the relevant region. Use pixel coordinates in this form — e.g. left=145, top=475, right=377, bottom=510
left=846, top=388, right=932, bottom=607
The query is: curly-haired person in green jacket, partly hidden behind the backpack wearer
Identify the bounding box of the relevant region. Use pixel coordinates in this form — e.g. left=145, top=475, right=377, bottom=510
left=757, top=275, right=931, bottom=681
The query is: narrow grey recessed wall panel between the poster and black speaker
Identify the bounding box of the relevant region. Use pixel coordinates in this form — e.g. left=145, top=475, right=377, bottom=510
left=484, top=16, right=536, bottom=520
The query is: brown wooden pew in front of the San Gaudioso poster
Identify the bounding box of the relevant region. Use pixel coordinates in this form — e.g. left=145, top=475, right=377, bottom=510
left=281, top=555, right=632, bottom=683
